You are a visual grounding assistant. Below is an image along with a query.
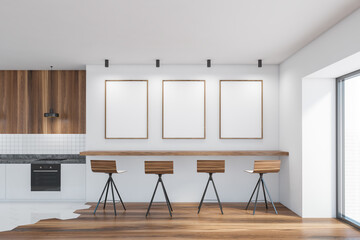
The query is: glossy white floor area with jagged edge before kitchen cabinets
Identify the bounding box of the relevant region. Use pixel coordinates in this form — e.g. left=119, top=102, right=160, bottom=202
left=0, top=202, right=90, bottom=232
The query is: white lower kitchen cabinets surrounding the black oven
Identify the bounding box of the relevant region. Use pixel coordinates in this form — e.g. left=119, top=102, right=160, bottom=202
left=4, top=164, right=85, bottom=200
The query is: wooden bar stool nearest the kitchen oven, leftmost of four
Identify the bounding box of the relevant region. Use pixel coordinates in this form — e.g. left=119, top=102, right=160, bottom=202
left=91, top=160, right=126, bottom=216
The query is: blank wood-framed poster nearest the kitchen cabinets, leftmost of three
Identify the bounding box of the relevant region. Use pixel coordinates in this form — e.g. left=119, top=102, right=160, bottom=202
left=105, top=80, right=148, bottom=139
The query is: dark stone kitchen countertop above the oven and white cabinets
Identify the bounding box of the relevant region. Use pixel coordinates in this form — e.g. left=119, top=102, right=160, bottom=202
left=0, top=154, right=86, bottom=164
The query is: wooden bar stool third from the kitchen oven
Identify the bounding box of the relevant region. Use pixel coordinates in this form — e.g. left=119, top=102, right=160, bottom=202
left=197, top=160, right=225, bottom=214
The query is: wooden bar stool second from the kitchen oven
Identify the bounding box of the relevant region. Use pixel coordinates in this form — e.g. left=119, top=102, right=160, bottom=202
left=145, top=161, right=174, bottom=217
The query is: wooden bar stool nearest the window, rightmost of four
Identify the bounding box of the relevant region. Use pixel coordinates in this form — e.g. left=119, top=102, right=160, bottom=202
left=245, top=160, right=281, bottom=215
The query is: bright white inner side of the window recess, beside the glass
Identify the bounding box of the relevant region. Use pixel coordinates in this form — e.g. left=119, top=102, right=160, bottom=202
left=302, top=78, right=336, bottom=218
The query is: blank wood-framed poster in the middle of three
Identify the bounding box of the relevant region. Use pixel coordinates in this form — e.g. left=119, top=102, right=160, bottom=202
left=162, top=80, right=206, bottom=139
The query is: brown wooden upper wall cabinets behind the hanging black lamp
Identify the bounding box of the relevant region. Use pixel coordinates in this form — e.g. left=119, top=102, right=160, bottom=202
left=0, top=70, right=86, bottom=134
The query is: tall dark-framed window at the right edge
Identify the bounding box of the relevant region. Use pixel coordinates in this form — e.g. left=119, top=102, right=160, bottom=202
left=337, top=70, right=360, bottom=227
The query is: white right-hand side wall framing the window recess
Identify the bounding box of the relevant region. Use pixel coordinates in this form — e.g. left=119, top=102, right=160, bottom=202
left=279, top=10, right=360, bottom=216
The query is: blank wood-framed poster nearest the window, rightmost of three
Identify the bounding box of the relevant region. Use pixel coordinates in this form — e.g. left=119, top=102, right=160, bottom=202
left=219, top=80, right=263, bottom=139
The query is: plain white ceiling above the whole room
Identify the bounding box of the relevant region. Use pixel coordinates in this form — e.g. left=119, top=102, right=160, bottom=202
left=0, top=0, right=360, bottom=69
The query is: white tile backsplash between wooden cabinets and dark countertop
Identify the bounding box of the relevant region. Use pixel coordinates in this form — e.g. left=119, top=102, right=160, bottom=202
left=0, top=134, right=85, bottom=154
